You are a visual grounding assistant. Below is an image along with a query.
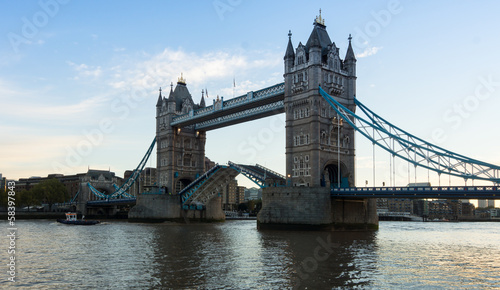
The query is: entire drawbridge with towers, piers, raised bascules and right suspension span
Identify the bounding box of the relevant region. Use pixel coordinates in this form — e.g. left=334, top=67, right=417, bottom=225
left=126, top=13, right=500, bottom=230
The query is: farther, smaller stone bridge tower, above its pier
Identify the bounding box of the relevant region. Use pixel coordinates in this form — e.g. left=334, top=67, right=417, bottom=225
left=156, top=75, right=206, bottom=194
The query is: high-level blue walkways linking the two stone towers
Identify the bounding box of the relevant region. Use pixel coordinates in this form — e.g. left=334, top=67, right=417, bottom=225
left=171, top=83, right=285, bottom=131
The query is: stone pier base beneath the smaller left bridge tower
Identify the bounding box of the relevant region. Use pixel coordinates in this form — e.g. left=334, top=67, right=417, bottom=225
left=128, top=194, right=226, bottom=223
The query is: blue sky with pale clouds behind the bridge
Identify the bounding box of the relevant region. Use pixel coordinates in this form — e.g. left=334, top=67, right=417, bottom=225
left=0, top=0, right=500, bottom=199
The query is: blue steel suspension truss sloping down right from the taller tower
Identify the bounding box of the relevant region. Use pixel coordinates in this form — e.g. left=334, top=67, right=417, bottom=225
left=319, top=87, right=500, bottom=184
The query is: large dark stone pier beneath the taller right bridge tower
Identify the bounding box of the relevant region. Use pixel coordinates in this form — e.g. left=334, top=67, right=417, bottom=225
left=257, top=187, right=378, bottom=230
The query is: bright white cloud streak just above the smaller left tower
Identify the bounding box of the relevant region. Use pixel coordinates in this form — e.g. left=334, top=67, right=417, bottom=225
left=108, top=48, right=282, bottom=101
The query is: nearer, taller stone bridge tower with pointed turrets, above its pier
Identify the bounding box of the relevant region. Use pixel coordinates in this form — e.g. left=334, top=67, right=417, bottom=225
left=284, top=11, right=356, bottom=187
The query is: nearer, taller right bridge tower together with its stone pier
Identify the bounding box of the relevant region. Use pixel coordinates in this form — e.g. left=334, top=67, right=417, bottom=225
left=257, top=11, right=378, bottom=230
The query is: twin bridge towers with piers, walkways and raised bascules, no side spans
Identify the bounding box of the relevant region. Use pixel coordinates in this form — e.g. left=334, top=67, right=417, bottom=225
left=129, top=15, right=372, bottom=227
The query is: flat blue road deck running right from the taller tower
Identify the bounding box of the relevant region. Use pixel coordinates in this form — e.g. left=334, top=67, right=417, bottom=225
left=331, top=186, right=500, bottom=199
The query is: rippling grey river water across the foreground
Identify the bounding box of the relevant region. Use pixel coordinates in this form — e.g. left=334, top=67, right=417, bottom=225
left=4, top=220, right=500, bottom=289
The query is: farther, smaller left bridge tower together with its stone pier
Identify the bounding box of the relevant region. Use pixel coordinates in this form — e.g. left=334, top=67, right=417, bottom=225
left=128, top=75, right=225, bottom=222
